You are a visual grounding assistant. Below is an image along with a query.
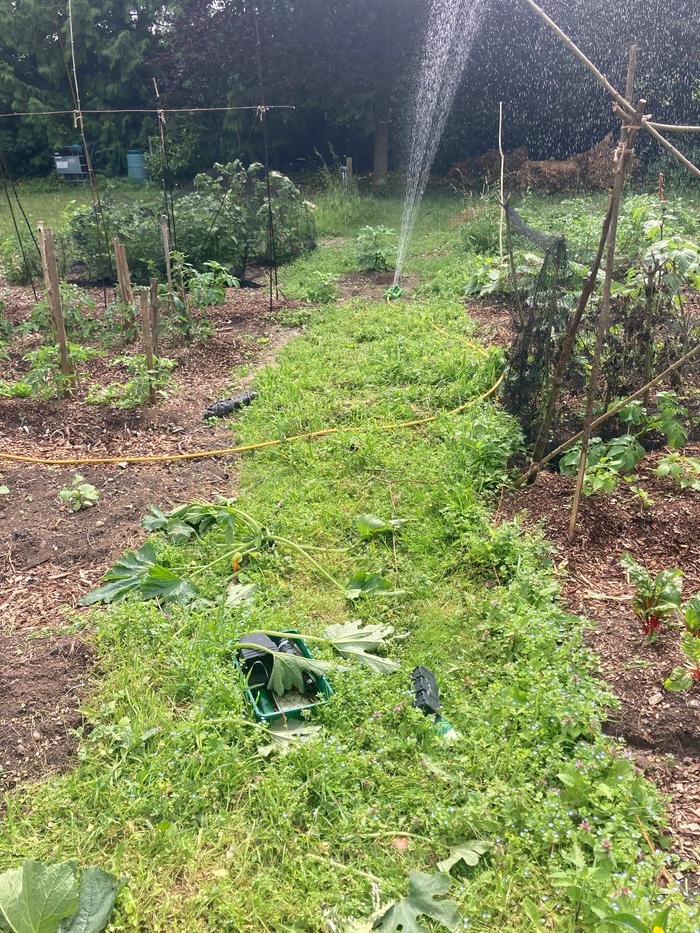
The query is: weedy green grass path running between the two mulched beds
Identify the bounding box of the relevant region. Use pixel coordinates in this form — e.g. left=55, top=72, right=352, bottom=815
left=0, top=200, right=697, bottom=933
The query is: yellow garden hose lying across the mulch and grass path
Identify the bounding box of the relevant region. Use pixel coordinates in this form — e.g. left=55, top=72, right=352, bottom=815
left=0, top=373, right=505, bottom=466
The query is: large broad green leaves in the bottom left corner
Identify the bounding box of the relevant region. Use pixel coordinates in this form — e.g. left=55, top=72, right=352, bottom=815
left=0, top=861, right=119, bottom=933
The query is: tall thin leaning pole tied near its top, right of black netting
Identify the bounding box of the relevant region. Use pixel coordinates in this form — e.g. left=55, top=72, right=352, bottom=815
left=569, top=52, right=646, bottom=541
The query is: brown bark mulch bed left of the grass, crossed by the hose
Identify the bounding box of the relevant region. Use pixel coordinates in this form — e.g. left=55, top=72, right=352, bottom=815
left=0, top=289, right=304, bottom=792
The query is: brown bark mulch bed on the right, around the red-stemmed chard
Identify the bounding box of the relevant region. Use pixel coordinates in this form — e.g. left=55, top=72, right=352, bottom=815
left=501, top=447, right=700, bottom=860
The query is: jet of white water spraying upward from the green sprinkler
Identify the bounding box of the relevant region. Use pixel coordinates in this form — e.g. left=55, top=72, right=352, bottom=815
left=394, top=0, right=484, bottom=285
